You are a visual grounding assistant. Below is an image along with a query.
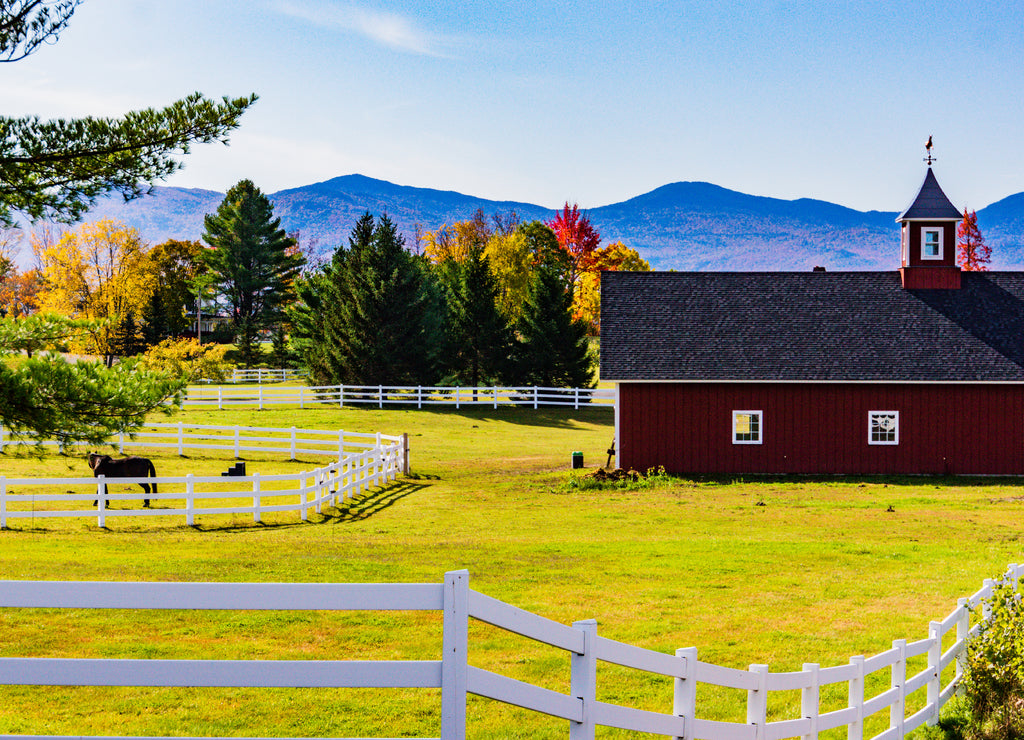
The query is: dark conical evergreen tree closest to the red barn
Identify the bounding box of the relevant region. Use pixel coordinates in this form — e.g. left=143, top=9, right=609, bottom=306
left=516, top=265, right=594, bottom=388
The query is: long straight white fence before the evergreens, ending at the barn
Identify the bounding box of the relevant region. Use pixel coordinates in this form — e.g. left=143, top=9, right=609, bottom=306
left=184, top=386, right=615, bottom=409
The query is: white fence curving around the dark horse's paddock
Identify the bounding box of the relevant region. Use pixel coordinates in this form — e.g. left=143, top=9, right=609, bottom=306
left=0, top=424, right=409, bottom=529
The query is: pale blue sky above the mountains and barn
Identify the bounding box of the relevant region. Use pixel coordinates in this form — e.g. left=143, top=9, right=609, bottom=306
left=8, top=0, right=1024, bottom=211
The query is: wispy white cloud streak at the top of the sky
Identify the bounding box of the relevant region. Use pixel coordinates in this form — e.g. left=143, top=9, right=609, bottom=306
left=274, top=0, right=452, bottom=57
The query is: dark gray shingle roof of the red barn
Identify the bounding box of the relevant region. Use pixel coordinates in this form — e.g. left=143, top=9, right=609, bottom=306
left=601, top=271, right=1024, bottom=381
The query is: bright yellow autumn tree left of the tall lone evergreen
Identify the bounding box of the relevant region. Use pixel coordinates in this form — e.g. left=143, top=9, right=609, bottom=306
left=32, top=219, right=156, bottom=365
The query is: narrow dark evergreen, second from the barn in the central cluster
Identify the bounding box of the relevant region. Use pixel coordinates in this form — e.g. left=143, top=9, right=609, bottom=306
left=437, top=244, right=512, bottom=387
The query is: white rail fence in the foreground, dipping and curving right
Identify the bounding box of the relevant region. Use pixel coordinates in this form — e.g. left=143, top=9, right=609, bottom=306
left=0, top=565, right=1024, bottom=740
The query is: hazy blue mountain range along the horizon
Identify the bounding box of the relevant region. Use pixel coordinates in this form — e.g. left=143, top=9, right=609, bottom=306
left=75, top=175, right=1024, bottom=271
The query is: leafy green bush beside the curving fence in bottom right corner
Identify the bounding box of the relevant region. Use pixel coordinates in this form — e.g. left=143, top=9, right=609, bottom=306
left=963, top=580, right=1024, bottom=740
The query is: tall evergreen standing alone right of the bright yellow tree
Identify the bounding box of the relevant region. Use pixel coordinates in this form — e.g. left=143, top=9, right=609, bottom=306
left=203, top=180, right=305, bottom=367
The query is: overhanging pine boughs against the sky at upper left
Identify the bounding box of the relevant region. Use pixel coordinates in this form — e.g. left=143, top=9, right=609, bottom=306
left=0, top=0, right=256, bottom=224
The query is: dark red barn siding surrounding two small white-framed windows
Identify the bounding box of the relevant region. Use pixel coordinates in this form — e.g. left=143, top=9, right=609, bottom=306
left=617, top=383, right=1024, bottom=475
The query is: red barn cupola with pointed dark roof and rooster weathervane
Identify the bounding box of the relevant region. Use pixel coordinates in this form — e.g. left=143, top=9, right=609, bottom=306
left=896, top=137, right=964, bottom=290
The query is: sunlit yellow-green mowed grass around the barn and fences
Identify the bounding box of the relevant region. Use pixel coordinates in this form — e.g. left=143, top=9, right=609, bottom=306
left=0, top=408, right=1024, bottom=738
